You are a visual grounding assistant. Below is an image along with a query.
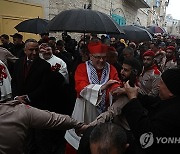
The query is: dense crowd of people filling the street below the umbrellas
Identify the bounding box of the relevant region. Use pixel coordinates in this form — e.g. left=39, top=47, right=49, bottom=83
left=0, top=32, right=180, bottom=154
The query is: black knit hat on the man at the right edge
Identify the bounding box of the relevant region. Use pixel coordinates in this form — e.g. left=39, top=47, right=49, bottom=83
left=161, top=68, right=180, bottom=96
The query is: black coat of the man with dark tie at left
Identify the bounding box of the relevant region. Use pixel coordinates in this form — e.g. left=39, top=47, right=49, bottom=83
left=11, top=57, right=51, bottom=109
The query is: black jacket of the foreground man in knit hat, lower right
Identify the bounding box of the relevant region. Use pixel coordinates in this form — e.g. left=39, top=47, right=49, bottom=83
left=122, top=96, right=180, bottom=154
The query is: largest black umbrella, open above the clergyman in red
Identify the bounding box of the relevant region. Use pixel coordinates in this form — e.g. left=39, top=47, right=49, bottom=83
left=48, top=9, right=123, bottom=34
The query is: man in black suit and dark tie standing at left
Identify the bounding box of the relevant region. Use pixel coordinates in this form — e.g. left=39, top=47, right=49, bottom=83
left=11, top=39, right=51, bottom=109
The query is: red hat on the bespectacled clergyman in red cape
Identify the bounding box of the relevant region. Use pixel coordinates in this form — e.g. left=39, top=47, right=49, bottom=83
left=88, top=42, right=108, bottom=54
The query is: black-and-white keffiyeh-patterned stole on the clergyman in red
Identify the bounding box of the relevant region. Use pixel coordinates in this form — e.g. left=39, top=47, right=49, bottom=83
left=86, top=60, right=110, bottom=113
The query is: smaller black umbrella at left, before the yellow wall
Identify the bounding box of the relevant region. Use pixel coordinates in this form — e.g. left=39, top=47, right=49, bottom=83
left=14, top=17, right=48, bottom=34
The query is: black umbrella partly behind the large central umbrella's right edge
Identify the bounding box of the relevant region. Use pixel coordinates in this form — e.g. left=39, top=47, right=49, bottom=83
left=121, top=25, right=153, bottom=42
